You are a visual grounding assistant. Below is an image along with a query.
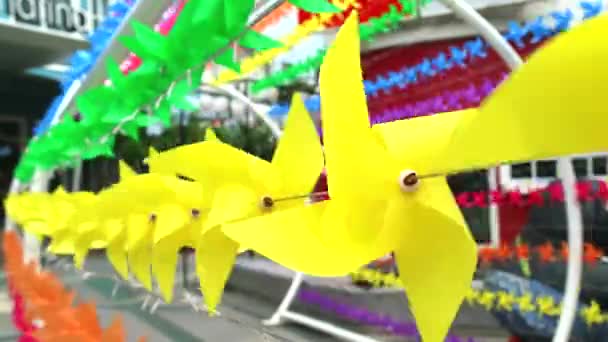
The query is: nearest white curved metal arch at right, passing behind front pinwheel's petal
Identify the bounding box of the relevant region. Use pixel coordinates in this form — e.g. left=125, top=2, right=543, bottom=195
left=441, top=0, right=583, bottom=342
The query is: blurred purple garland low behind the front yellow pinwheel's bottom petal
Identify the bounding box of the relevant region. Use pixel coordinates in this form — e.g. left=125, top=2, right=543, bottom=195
left=298, top=289, right=474, bottom=342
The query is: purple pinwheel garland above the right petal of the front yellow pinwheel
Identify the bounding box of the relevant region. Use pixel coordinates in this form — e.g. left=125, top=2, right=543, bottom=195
left=371, top=74, right=507, bottom=124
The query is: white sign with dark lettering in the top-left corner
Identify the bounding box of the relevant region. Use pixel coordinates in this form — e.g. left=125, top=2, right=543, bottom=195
left=0, top=0, right=108, bottom=36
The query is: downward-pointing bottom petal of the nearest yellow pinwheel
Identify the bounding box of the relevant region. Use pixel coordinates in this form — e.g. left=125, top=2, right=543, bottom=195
left=386, top=178, right=477, bottom=342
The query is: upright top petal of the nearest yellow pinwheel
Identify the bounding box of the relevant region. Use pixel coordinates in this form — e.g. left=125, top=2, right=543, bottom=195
left=320, top=12, right=398, bottom=203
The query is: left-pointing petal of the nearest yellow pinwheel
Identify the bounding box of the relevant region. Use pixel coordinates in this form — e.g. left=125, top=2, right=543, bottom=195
left=222, top=202, right=371, bottom=277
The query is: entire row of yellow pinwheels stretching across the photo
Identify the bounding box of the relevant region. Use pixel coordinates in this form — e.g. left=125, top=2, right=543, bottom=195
left=7, top=12, right=608, bottom=342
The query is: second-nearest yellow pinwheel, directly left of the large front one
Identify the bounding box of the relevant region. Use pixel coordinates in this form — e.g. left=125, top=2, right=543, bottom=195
left=149, top=95, right=323, bottom=313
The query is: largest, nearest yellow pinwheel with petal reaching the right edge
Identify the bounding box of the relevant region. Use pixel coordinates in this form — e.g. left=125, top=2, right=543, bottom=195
left=218, top=10, right=608, bottom=342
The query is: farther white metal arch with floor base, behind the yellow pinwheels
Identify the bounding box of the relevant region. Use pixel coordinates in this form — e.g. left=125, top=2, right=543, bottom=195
left=213, top=85, right=377, bottom=342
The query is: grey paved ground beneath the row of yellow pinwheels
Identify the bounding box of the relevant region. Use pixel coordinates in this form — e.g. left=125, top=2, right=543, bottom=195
left=0, top=260, right=505, bottom=342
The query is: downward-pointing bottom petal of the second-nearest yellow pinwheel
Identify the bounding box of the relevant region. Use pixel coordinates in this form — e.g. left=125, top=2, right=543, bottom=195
left=196, top=228, right=238, bottom=314
